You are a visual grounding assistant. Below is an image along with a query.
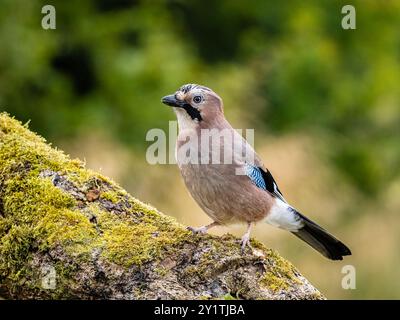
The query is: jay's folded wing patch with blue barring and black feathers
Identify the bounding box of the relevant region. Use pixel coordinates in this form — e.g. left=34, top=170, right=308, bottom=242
left=245, top=163, right=287, bottom=203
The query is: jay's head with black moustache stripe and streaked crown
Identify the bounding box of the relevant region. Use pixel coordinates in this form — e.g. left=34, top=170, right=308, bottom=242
left=161, top=84, right=223, bottom=127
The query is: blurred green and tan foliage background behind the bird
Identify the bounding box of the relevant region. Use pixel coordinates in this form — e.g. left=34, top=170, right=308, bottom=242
left=0, top=0, right=400, bottom=299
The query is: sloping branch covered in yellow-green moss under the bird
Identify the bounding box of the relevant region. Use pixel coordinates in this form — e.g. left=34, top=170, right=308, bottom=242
left=0, top=113, right=323, bottom=299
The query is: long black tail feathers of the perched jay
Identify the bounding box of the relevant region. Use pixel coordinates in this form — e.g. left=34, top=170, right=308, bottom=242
left=292, top=211, right=351, bottom=260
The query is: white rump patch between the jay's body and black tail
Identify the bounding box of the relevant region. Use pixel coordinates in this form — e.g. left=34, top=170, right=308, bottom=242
left=265, top=199, right=304, bottom=232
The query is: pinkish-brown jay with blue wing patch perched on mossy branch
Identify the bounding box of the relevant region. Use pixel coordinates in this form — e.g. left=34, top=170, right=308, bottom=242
left=161, top=84, right=351, bottom=260
